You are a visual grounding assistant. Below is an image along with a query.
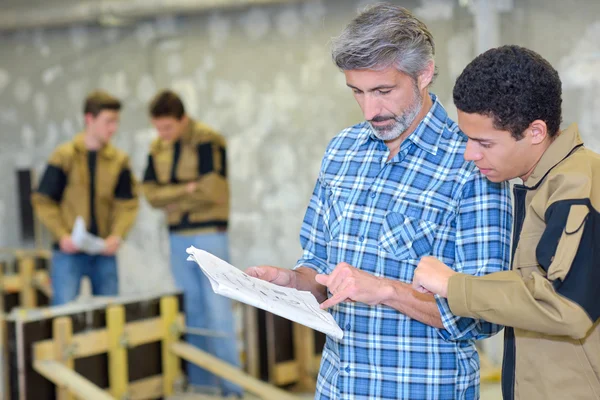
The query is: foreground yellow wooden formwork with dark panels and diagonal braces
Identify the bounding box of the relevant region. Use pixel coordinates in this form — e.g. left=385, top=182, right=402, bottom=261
left=2, top=293, right=295, bottom=400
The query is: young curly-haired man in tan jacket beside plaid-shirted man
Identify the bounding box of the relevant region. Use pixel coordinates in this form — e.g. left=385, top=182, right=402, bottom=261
left=413, top=46, right=600, bottom=400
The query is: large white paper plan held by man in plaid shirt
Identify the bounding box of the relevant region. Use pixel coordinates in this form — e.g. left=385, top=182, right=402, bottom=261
left=186, top=246, right=344, bottom=339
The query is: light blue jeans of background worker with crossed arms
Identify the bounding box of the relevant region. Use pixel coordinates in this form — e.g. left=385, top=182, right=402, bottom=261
left=169, top=232, right=242, bottom=396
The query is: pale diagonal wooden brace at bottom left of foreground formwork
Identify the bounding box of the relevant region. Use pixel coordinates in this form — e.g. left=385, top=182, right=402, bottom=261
left=33, top=361, right=114, bottom=400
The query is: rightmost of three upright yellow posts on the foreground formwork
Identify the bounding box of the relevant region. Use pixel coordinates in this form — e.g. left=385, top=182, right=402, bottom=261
left=160, top=296, right=181, bottom=396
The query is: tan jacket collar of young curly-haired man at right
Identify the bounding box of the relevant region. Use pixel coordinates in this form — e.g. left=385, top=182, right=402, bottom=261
left=525, top=124, right=583, bottom=188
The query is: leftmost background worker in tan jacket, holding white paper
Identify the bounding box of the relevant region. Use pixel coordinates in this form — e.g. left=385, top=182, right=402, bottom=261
left=32, top=91, right=138, bottom=305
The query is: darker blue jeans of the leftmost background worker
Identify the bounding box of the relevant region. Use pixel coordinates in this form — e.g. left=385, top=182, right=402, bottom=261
left=50, top=250, right=119, bottom=306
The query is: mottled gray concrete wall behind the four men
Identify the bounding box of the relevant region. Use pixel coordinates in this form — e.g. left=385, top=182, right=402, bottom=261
left=0, top=0, right=600, bottom=293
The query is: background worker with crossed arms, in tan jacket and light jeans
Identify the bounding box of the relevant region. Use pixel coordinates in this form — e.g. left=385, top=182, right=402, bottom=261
left=143, top=90, right=242, bottom=397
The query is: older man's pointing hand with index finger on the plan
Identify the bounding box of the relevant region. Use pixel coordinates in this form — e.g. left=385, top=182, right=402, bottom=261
left=315, top=263, right=389, bottom=309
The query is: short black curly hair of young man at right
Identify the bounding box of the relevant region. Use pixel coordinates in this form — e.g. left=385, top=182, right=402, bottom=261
left=453, top=46, right=562, bottom=140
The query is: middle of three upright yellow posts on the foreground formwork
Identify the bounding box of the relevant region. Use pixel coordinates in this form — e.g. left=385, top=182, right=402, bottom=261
left=106, top=305, right=129, bottom=399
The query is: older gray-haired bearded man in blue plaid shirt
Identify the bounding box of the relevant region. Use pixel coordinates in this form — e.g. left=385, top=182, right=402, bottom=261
left=248, top=4, right=512, bottom=400
